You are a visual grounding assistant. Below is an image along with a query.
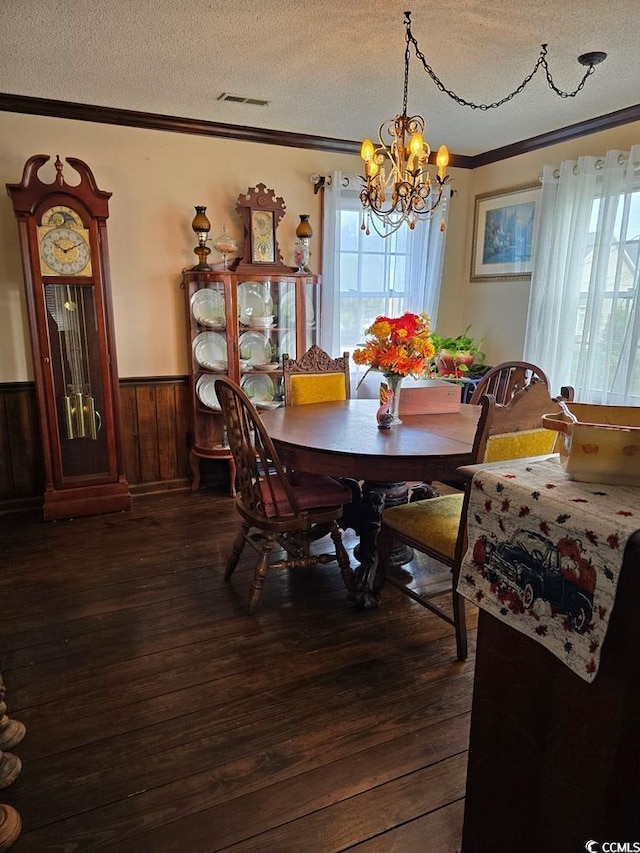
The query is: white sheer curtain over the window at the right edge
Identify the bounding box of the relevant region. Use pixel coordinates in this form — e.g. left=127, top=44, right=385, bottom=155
left=524, top=145, right=640, bottom=405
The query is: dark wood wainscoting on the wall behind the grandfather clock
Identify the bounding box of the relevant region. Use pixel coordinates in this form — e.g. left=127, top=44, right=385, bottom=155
left=0, top=376, right=228, bottom=512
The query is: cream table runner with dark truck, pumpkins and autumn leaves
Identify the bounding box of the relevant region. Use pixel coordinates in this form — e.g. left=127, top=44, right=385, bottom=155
left=458, top=457, right=640, bottom=682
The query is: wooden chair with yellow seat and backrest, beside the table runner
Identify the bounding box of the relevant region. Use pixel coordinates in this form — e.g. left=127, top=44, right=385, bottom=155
left=374, top=382, right=557, bottom=660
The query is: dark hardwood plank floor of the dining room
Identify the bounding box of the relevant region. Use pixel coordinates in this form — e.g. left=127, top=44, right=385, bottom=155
left=0, top=492, right=475, bottom=853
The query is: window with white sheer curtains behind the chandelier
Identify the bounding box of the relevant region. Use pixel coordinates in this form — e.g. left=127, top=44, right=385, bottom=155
left=320, top=172, right=446, bottom=354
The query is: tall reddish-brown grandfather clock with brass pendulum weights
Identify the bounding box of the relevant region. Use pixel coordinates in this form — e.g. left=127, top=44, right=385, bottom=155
left=7, top=154, right=131, bottom=520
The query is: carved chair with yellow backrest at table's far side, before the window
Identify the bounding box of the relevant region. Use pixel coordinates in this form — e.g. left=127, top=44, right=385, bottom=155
left=282, top=344, right=351, bottom=406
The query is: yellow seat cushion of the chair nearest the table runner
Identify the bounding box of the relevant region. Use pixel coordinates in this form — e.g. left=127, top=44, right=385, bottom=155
left=382, top=494, right=464, bottom=560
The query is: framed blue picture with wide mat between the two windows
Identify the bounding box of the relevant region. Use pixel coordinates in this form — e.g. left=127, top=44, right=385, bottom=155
left=471, top=183, right=540, bottom=281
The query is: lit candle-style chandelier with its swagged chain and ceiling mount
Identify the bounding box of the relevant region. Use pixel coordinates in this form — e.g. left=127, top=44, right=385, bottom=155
left=360, top=12, right=607, bottom=237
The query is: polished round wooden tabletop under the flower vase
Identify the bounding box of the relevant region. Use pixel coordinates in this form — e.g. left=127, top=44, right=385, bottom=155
left=261, top=400, right=480, bottom=481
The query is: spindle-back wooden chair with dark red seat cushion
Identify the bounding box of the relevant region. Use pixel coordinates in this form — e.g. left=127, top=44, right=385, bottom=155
left=215, top=376, right=353, bottom=615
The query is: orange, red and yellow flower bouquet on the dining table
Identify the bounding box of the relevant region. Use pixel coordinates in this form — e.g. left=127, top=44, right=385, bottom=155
left=353, top=312, right=435, bottom=377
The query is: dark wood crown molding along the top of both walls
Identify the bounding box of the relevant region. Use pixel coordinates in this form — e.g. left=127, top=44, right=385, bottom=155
left=0, top=93, right=640, bottom=169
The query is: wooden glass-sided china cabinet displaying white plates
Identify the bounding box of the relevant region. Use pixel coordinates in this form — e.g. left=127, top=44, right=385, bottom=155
left=182, top=266, right=320, bottom=494
